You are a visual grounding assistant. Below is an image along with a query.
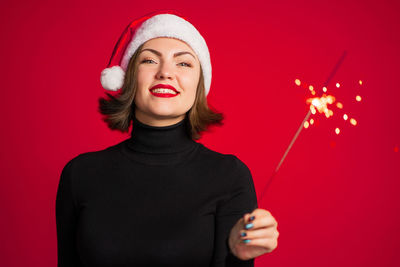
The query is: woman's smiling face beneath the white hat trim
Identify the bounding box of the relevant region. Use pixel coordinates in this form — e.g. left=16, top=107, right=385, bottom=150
left=134, top=37, right=200, bottom=126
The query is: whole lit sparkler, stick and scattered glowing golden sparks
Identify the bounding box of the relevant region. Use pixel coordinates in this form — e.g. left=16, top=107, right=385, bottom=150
left=254, top=51, right=348, bottom=209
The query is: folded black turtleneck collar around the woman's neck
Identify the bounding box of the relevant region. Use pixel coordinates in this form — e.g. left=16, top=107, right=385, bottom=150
left=127, top=116, right=197, bottom=154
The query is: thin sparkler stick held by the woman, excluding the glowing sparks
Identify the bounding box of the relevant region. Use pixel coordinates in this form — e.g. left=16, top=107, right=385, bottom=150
left=253, top=51, right=347, bottom=209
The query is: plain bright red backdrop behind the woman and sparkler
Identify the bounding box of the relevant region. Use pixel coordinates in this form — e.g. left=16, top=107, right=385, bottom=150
left=0, top=0, right=400, bottom=267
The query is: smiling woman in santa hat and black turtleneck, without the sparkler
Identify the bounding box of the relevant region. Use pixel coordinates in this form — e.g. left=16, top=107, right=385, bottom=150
left=56, top=12, right=278, bottom=267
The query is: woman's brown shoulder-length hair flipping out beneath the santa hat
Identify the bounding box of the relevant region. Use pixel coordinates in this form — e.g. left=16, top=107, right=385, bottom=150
left=99, top=44, right=224, bottom=140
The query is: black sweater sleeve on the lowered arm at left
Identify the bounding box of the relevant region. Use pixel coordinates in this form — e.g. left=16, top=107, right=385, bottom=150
left=56, top=160, right=81, bottom=267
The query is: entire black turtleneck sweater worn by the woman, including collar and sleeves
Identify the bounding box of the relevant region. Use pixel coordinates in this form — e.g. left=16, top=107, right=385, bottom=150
left=56, top=117, right=257, bottom=267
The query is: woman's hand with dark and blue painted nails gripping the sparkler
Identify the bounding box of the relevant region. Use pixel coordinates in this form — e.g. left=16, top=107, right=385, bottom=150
left=229, top=209, right=279, bottom=260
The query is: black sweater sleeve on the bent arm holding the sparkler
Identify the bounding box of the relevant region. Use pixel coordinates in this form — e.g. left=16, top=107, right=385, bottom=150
left=211, top=155, right=258, bottom=267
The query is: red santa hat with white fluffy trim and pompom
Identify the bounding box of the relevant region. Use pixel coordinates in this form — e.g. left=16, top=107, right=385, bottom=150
left=100, top=10, right=211, bottom=96
